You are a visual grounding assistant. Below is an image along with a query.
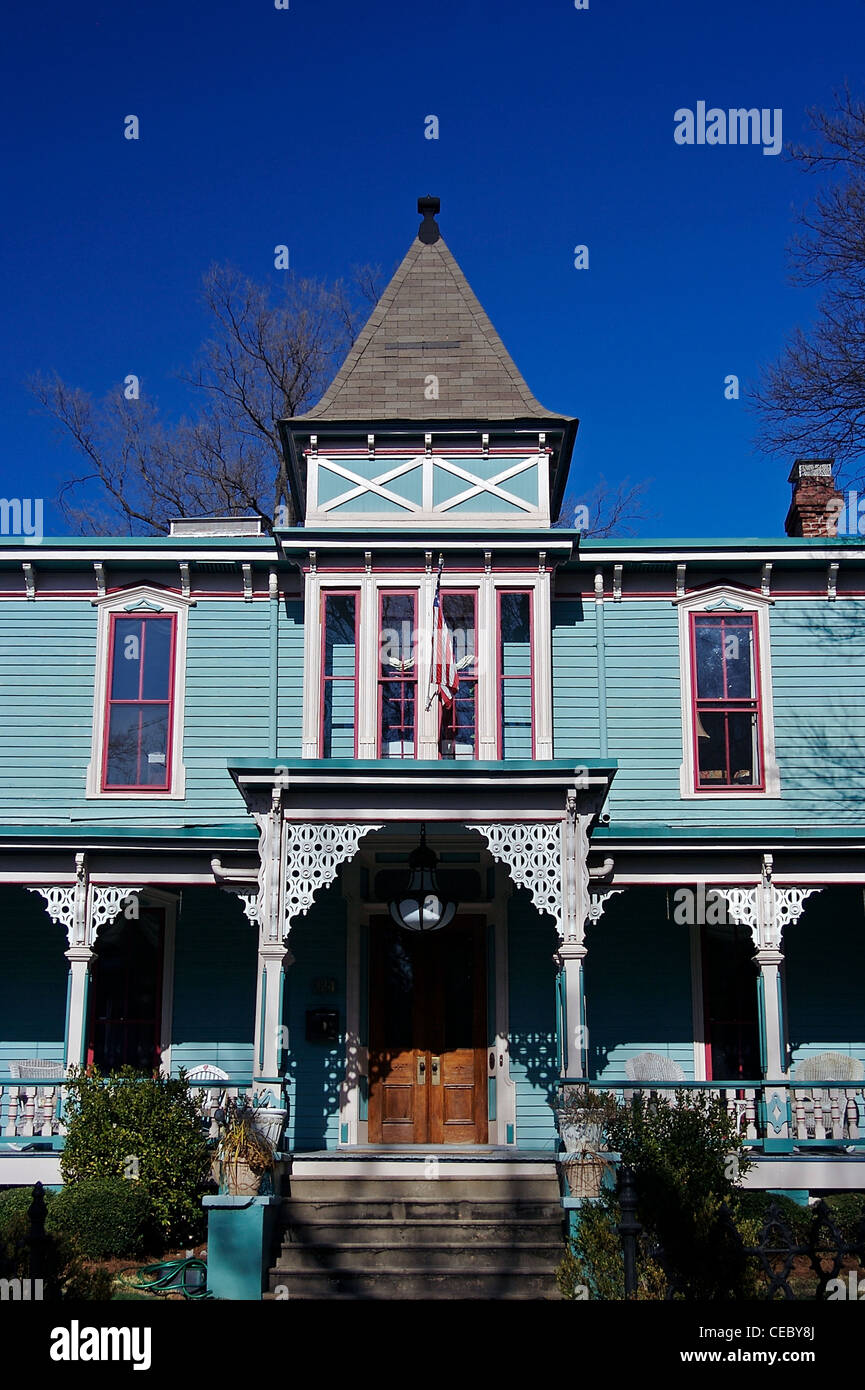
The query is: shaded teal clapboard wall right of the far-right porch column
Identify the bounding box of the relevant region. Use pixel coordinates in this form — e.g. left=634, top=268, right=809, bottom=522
left=783, top=885, right=865, bottom=1068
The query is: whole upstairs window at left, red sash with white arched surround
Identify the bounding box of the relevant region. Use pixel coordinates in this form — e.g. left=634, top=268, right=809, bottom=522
left=88, top=585, right=191, bottom=798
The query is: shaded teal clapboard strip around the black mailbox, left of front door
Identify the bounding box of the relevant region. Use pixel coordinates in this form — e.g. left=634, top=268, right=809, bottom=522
left=282, top=884, right=345, bottom=1151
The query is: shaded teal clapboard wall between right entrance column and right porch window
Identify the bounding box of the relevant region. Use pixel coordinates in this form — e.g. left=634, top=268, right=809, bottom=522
left=585, top=888, right=694, bottom=1081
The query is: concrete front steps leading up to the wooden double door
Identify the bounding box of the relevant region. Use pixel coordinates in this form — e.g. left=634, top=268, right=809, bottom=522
left=264, top=1151, right=565, bottom=1300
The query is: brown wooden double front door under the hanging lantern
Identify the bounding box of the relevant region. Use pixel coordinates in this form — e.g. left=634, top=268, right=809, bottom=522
left=369, top=917, right=488, bottom=1144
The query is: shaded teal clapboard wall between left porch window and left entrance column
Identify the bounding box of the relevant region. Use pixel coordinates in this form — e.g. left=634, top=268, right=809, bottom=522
left=171, top=888, right=257, bottom=1077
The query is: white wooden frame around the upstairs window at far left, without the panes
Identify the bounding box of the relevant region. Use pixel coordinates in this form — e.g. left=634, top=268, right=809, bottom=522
left=86, top=584, right=195, bottom=802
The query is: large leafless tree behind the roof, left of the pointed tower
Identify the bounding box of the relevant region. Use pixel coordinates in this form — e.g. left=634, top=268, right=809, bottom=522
left=31, top=265, right=381, bottom=535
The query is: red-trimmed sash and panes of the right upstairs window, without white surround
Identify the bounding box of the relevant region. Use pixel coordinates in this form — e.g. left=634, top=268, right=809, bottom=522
left=691, top=613, right=763, bottom=791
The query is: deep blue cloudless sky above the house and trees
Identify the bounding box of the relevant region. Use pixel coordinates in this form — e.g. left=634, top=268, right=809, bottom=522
left=0, top=0, right=865, bottom=535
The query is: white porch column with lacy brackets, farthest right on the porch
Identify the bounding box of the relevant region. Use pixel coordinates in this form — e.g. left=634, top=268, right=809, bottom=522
left=720, top=855, right=820, bottom=1151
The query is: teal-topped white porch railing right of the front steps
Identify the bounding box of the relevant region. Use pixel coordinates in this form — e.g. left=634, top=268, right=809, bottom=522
left=559, top=1077, right=865, bottom=1148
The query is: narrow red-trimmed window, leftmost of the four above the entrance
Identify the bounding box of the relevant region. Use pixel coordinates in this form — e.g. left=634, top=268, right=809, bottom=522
left=318, top=589, right=360, bottom=758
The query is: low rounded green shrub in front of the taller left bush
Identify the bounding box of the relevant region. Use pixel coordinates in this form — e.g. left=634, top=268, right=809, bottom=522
left=46, top=1177, right=156, bottom=1259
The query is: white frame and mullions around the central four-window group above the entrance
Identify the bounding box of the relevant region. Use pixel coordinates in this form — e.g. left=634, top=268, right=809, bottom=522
left=303, top=570, right=552, bottom=762
